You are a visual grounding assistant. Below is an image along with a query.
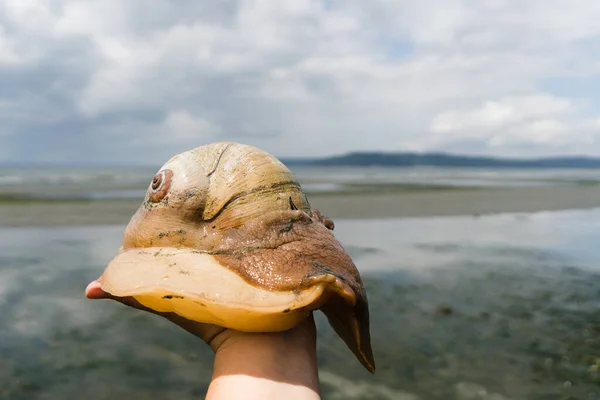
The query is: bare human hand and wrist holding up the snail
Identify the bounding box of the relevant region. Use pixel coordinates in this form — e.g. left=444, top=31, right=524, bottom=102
left=86, top=281, right=320, bottom=400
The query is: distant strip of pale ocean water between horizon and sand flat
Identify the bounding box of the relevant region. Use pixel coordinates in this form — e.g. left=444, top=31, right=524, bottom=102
left=0, top=166, right=600, bottom=200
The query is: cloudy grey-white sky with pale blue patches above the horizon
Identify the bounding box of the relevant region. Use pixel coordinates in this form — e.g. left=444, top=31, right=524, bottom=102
left=0, top=0, right=600, bottom=164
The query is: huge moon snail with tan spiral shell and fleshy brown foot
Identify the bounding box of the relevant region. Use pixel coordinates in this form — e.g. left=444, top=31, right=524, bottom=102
left=89, top=142, right=375, bottom=372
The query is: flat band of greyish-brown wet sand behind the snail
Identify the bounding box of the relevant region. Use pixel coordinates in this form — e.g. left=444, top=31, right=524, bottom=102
left=0, top=186, right=600, bottom=227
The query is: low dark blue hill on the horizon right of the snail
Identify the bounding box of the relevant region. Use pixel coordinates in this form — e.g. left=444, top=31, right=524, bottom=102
left=282, top=152, right=600, bottom=168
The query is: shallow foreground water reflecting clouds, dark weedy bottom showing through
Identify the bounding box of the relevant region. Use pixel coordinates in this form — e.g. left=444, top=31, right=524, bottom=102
left=0, top=210, right=600, bottom=400
